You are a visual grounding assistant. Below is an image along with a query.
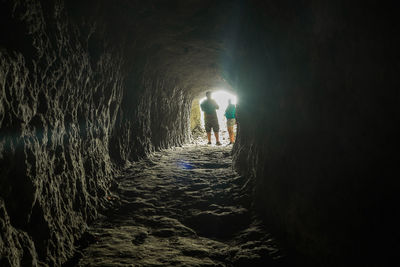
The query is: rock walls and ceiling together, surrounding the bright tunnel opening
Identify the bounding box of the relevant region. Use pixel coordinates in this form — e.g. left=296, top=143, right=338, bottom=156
left=0, top=0, right=400, bottom=266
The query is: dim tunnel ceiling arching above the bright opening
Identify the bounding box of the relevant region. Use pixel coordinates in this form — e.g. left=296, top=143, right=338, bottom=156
left=82, top=0, right=237, bottom=96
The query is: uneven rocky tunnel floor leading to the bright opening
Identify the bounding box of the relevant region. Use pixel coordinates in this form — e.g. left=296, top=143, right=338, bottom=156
left=71, top=145, right=285, bottom=266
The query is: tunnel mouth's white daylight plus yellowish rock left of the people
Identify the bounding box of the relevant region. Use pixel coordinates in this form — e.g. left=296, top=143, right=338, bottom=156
left=190, top=90, right=238, bottom=145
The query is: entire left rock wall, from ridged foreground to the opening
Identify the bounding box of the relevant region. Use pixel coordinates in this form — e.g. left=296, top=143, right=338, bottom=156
left=0, top=0, right=190, bottom=266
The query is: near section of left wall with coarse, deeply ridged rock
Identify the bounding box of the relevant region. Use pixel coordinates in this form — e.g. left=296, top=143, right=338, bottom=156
left=0, top=1, right=122, bottom=266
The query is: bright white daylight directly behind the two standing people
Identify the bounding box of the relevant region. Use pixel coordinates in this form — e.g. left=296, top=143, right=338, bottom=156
left=199, top=90, right=237, bottom=143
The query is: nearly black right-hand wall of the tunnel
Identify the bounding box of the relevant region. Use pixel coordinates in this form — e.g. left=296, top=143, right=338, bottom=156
left=228, top=1, right=400, bottom=266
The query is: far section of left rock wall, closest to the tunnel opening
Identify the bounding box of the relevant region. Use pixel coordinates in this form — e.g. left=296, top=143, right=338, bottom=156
left=112, top=69, right=191, bottom=163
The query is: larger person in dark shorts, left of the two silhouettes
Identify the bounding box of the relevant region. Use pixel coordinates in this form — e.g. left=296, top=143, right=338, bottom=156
left=200, top=91, right=221, bottom=146
